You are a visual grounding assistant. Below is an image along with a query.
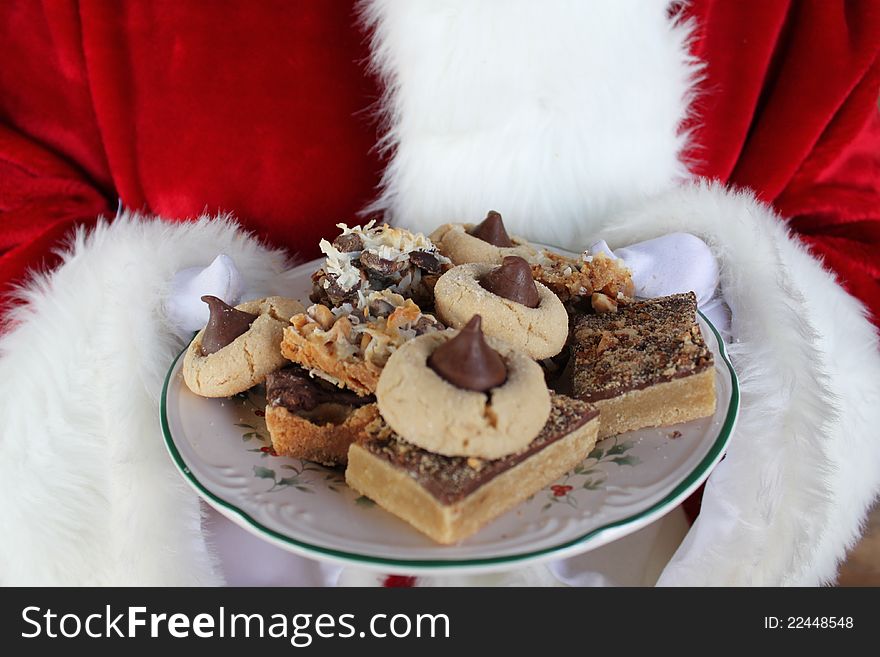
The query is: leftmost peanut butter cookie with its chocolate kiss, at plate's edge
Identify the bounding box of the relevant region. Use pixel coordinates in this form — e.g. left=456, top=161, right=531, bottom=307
left=183, top=296, right=303, bottom=397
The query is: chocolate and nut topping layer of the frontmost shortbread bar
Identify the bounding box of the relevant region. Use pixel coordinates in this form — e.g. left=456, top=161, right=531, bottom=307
left=361, top=394, right=599, bottom=504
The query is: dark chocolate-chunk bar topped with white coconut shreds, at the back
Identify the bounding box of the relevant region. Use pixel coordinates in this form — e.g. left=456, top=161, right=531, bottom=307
left=310, top=221, right=450, bottom=308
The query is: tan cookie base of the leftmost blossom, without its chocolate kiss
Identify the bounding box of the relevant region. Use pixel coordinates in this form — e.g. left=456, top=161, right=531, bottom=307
left=183, top=297, right=304, bottom=397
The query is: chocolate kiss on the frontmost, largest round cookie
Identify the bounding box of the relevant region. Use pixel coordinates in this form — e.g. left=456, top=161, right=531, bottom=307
left=428, top=315, right=507, bottom=392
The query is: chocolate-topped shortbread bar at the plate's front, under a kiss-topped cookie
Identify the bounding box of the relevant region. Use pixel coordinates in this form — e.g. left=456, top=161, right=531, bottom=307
left=345, top=395, right=599, bottom=544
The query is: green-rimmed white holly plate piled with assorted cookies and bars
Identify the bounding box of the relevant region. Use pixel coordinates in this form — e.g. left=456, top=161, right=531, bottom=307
left=161, top=212, right=739, bottom=574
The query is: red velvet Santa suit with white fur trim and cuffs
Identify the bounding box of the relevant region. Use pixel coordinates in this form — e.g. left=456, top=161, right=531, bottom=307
left=0, top=0, right=880, bottom=584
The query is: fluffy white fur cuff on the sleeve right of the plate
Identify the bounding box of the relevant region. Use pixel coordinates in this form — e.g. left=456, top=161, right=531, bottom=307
left=601, top=182, right=880, bottom=585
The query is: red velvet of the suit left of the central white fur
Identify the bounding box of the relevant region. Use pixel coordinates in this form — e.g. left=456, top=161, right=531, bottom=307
left=0, top=0, right=381, bottom=304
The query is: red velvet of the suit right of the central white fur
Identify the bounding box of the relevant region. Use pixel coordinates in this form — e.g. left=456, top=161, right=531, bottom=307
left=688, top=0, right=880, bottom=321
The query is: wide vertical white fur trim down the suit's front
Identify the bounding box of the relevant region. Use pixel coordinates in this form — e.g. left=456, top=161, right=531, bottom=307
left=363, top=0, right=699, bottom=246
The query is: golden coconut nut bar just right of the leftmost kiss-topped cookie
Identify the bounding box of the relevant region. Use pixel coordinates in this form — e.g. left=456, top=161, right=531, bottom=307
left=281, top=290, right=445, bottom=395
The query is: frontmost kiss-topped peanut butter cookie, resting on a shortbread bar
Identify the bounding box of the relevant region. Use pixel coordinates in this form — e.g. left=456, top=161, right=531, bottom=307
left=376, top=316, right=550, bottom=459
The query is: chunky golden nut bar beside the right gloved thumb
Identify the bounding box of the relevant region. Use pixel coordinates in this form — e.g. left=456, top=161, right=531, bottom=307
left=531, top=250, right=635, bottom=313
